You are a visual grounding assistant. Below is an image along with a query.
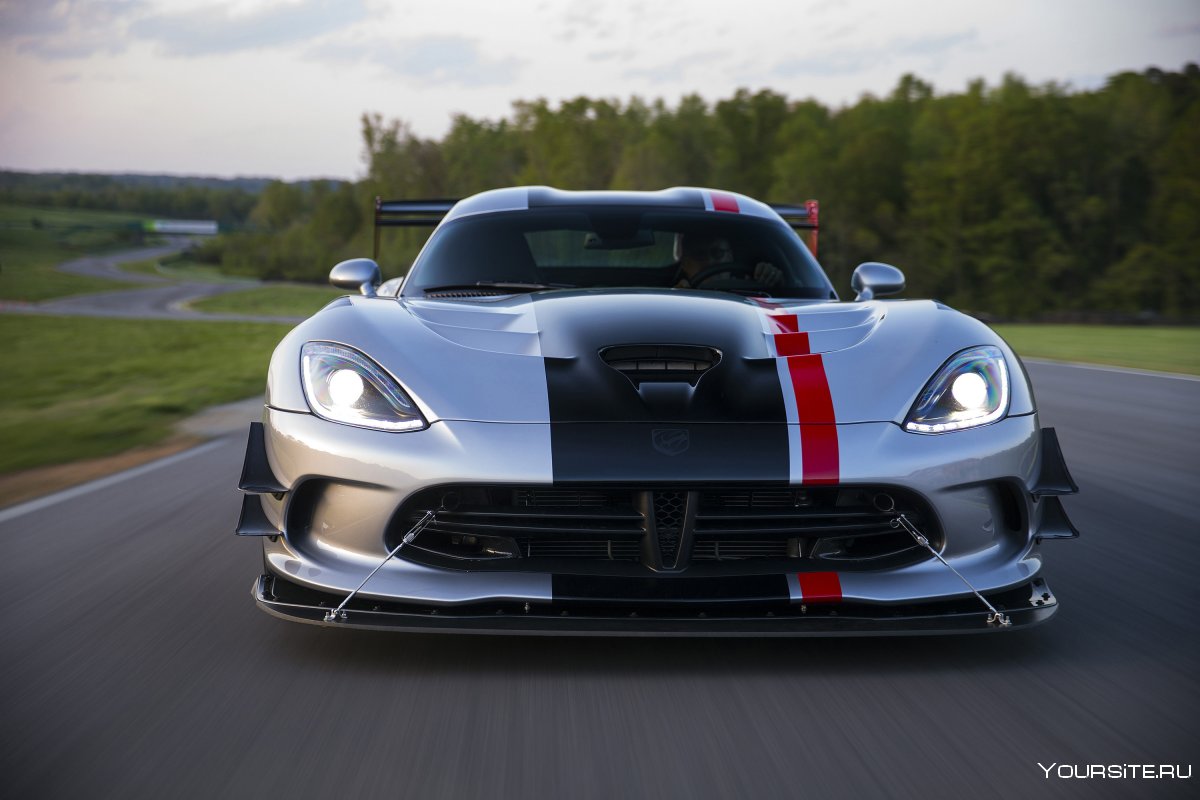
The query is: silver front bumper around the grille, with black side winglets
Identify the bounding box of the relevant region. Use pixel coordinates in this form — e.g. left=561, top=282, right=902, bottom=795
left=239, top=411, right=1074, bottom=636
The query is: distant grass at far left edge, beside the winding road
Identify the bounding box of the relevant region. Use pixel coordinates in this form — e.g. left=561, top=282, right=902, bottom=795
left=0, top=205, right=142, bottom=302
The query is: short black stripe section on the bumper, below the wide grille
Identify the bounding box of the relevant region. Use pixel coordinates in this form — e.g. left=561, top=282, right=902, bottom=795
left=551, top=575, right=791, bottom=606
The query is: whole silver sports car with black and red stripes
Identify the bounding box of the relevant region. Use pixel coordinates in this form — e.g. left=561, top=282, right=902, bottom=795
left=238, top=187, right=1078, bottom=636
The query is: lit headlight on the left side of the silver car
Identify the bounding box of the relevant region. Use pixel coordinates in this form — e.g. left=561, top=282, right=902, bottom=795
left=300, top=342, right=428, bottom=431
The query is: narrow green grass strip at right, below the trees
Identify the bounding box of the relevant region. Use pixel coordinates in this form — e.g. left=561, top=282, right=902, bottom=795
left=994, top=325, right=1200, bottom=375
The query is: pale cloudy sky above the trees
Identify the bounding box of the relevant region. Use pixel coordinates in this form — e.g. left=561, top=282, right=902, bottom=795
left=0, top=0, right=1200, bottom=180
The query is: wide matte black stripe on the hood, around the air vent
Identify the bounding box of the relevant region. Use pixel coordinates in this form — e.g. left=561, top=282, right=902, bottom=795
left=535, top=290, right=790, bottom=482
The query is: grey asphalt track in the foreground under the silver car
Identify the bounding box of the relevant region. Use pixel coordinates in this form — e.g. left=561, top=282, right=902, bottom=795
left=0, top=365, right=1200, bottom=800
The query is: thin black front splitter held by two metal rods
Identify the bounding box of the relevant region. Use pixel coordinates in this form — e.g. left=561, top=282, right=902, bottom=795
left=252, top=575, right=1058, bottom=637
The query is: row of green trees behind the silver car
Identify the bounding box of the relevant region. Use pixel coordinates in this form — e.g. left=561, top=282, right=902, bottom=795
left=25, top=65, right=1200, bottom=320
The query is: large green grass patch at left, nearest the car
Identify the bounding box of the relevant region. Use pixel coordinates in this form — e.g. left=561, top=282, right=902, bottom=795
left=0, top=314, right=288, bottom=473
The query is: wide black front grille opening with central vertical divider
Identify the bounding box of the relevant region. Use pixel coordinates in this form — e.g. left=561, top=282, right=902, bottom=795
left=386, top=486, right=943, bottom=573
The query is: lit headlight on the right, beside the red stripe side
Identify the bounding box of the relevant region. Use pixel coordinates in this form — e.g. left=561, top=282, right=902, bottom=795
left=904, top=347, right=1008, bottom=433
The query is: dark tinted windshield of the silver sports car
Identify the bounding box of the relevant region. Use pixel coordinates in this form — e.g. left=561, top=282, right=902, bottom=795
left=402, top=206, right=836, bottom=299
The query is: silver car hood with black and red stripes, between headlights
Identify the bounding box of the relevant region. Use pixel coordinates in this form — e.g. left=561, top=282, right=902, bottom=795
left=268, top=289, right=1032, bottom=423
